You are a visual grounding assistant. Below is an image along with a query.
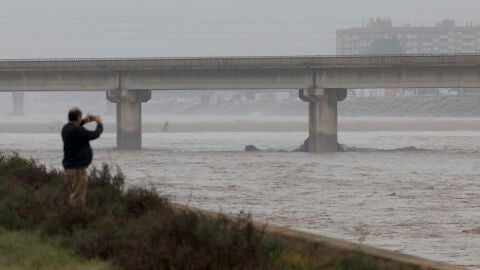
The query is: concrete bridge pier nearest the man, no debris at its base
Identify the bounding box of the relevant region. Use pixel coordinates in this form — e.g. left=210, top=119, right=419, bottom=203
left=107, top=90, right=152, bottom=150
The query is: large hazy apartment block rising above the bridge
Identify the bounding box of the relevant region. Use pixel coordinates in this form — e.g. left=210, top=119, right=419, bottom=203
left=337, top=19, right=480, bottom=55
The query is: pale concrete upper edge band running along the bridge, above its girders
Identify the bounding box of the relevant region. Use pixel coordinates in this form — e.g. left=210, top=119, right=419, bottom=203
left=0, top=54, right=480, bottom=71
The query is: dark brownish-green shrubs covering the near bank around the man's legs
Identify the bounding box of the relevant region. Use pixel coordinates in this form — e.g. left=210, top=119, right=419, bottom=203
left=0, top=154, right=373, bottom=270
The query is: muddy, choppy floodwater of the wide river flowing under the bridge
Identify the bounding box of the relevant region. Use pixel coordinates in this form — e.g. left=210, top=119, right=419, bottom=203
left=0, top=119, right=480, bottom=269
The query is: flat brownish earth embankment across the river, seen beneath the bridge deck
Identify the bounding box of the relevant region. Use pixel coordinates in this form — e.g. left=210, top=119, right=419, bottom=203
left=0, top=117, right=480, bottom=133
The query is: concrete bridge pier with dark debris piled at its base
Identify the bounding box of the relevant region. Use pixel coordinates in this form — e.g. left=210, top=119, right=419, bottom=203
left=300, top=88, right=347, bottom=153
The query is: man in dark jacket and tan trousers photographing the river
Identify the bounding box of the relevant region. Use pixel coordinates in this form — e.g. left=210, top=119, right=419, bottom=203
left=62, top=107, right=103, bottom=207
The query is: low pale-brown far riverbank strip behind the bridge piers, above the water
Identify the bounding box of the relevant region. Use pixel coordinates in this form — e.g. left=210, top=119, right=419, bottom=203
left=0, top=115, right=480, bottom=133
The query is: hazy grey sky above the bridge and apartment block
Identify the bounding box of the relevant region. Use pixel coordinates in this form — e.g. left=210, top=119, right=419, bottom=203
left=0, top=0, right=480, bottom=59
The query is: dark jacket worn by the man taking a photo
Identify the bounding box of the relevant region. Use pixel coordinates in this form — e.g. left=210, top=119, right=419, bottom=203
left=62, top=121, right=103, bottom=169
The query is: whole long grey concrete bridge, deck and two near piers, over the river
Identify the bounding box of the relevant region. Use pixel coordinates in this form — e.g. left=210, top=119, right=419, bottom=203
left=0, top=55, right=480, bottom=152
